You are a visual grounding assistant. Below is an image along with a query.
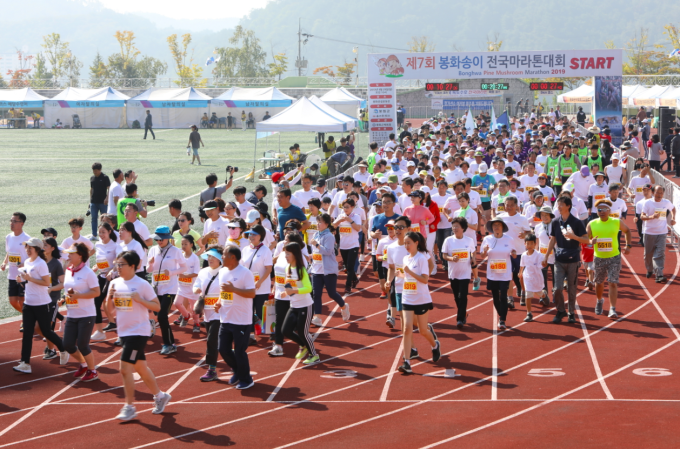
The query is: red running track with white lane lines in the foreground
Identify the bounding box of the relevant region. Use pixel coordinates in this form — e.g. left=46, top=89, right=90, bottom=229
left=0, top=208, right=680, bottom=449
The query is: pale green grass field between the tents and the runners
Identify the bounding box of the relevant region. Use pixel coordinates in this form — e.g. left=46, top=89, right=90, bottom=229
left=0, top=129, right=366, bottom=318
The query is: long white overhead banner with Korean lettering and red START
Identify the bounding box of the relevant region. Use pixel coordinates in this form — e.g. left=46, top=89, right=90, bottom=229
left=368, top=50, right=623, bottom=82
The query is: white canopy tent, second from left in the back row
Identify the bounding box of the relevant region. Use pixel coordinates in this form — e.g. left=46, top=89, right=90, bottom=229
left=45, top=87, right=130, bottom=128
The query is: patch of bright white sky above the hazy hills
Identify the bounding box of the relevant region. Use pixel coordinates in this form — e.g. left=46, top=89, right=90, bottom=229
left=99, top=0, right=270, bottom=19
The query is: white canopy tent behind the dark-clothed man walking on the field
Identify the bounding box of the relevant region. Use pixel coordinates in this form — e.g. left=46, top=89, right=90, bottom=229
left=127, top=87, right=211, bottom=128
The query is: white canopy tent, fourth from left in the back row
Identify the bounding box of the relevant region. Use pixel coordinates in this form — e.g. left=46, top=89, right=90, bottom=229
left=210, top=87, right=295, bottom=127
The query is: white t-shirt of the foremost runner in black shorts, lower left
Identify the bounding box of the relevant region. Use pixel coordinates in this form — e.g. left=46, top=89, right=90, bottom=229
left=110, top=276, right=156, bottom=337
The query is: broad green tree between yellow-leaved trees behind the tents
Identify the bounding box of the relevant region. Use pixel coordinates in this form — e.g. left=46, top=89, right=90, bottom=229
left=212, top=25, right=270, bottom=78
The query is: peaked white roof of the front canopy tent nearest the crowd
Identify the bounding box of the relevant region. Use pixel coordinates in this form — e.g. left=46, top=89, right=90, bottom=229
left=256, top=97, right=356, bottom=132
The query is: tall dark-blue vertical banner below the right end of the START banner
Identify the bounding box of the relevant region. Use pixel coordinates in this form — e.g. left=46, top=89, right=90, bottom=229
left=594, top=75, right=623, bottom=146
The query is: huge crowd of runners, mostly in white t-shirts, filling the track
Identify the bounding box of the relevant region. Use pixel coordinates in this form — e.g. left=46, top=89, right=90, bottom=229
left=0, top=114, right=680, bottom=420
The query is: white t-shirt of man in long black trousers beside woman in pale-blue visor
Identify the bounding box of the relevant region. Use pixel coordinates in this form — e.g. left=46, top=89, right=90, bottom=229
left=219, top=265, right=255, bottom=325
